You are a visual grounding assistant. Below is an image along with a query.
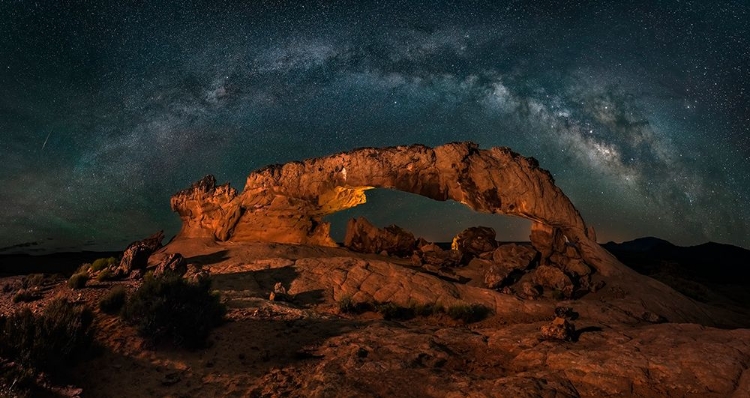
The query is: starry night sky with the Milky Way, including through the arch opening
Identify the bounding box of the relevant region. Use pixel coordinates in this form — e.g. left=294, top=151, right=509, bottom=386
left=0, top=0, right=750, bottom=252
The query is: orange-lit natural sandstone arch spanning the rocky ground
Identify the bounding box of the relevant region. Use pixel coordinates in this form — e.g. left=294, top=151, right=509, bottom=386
left=171, top=142, right=621, bottom=275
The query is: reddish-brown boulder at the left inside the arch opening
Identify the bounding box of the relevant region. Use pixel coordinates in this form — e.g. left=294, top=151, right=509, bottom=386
left=344, top=217, right=417, bottom=257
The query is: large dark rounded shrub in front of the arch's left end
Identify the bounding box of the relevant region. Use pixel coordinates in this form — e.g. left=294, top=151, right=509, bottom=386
left=122, top=274, right=226, bottom=348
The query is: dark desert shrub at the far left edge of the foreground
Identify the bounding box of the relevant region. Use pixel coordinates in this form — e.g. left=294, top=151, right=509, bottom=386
left=0, top=299, right=94, bottom=372
